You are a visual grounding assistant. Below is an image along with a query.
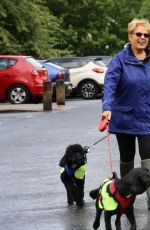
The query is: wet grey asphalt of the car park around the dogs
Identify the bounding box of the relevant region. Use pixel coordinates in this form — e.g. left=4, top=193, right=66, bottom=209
left=0, top=99, right=150, bottom=230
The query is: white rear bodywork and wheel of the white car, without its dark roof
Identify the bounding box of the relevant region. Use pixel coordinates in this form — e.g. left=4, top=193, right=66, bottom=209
left=69, top=61, right=107, bottom=99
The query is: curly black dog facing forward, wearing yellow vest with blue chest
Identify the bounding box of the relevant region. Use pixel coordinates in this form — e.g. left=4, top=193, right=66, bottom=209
left=59, top=144, right=88, bottom=207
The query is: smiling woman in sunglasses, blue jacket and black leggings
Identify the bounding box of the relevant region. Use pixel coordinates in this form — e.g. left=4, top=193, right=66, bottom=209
left=102, top=19, right=150, bottom=210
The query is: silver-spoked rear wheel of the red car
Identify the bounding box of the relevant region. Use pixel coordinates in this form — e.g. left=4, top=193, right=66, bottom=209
left=8, top=85, right=30, bottom=104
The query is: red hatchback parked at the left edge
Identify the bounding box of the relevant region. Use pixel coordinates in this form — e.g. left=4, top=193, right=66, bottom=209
left=0, top=55, right=49, bottom=104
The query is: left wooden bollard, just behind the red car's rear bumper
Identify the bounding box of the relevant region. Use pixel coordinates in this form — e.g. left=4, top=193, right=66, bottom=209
left=43, top=81, right=53, bottom=110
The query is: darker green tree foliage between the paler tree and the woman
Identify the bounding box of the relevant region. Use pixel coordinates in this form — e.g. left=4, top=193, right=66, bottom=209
left=47, top=0, right=141, bottom=55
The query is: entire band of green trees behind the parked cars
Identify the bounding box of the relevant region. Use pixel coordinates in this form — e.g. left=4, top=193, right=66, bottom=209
left=0, top=0, right=150, bottom=58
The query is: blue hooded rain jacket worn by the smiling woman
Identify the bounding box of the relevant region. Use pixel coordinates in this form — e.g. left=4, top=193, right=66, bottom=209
left=102, top=44, right=150, bottom=135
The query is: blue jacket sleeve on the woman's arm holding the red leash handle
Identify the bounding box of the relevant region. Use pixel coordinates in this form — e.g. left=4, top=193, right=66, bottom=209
left=102, top=55, right=122, bottom=111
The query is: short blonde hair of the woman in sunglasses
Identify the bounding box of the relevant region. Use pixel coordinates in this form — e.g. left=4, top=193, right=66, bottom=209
left=128, top=18, right=150, bottom=33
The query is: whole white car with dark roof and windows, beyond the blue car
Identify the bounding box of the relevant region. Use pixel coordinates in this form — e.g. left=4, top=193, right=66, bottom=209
left=48, top=56, right=107, bottom=99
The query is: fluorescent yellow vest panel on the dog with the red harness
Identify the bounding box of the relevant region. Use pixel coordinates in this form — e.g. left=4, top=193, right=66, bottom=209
left=99, top=179, right=118, bottom=211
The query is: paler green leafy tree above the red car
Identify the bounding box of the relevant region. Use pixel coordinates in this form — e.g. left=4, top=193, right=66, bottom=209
left=0, top=0, right=72, bottom=58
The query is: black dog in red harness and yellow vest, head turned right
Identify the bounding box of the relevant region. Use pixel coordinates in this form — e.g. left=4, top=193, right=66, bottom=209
left=90, top=168, right=150, bottom=230
